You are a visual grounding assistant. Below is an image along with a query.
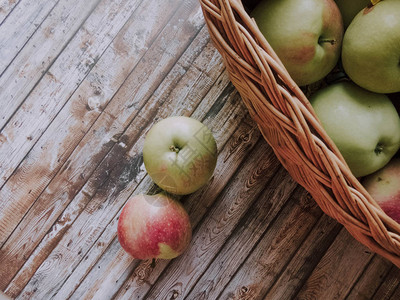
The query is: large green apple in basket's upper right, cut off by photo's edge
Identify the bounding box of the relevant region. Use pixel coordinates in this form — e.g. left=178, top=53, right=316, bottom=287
left=342, top=0, right=400, bottom=93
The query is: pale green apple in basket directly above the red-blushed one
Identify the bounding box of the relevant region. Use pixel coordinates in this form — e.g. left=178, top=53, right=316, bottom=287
left=310, top=81, right=400, bottom=177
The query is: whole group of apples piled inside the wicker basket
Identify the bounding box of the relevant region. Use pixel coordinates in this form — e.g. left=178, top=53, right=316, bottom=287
left=250, top=0, right=400, bottom=223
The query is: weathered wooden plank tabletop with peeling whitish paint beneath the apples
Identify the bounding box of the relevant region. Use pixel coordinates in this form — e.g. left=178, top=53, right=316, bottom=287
left=0, top=0, right=400, bottom=300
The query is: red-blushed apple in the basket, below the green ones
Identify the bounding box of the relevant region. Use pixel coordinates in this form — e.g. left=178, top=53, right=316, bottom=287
left=362, top=157, right=400, bottom=223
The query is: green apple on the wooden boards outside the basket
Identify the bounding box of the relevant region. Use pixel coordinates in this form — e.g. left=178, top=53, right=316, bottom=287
left=143, top=116, right=217, bottom=195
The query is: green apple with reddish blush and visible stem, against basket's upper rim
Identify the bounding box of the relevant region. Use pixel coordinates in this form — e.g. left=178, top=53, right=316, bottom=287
left=251, top=0, right=343, bottom=86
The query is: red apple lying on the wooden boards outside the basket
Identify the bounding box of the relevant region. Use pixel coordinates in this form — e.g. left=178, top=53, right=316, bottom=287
left=117, top=193, right=192, bottom=259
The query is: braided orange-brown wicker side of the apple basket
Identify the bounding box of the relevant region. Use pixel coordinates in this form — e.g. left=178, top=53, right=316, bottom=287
left=200, top=0, right=400, bottom=267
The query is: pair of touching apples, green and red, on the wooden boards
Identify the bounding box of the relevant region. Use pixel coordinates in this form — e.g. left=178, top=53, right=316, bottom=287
left=117, top=116, right=217, bottom=261
